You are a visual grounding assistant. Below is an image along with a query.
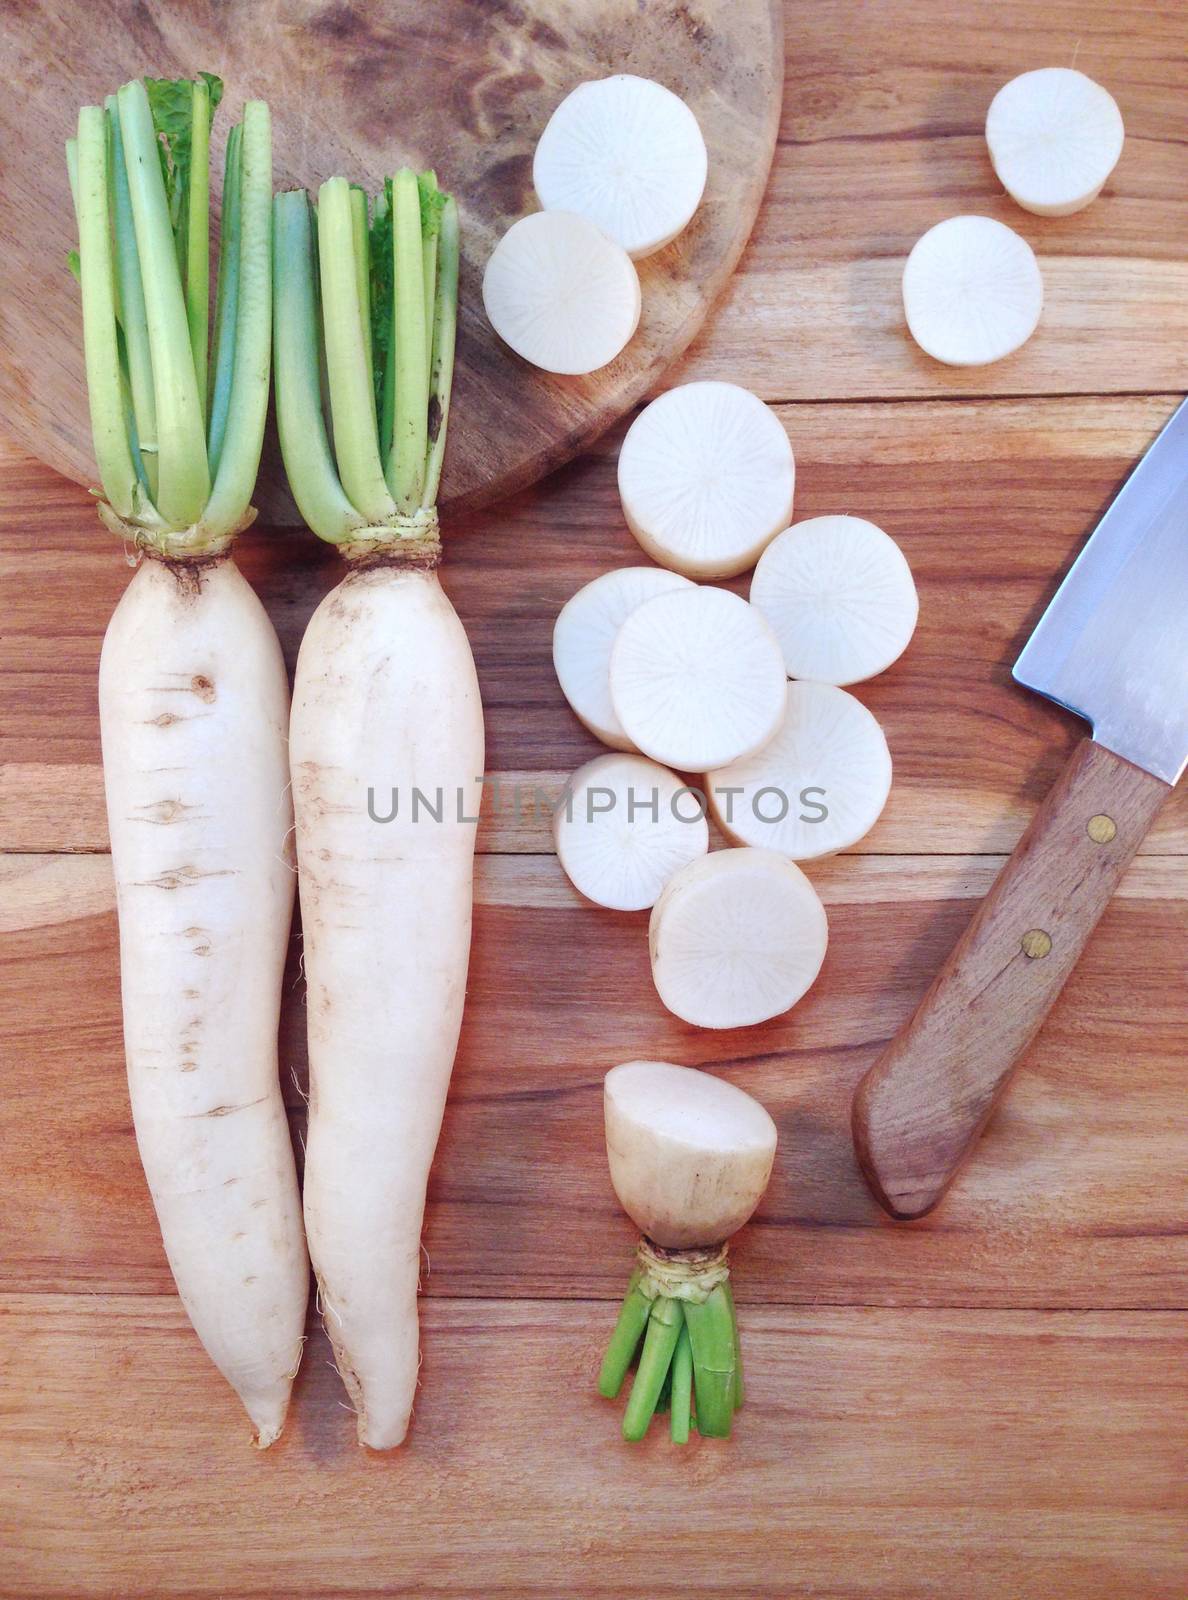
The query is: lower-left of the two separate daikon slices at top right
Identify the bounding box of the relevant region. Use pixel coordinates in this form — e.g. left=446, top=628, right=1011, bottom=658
left=903, top=216, right=1044, bottom=366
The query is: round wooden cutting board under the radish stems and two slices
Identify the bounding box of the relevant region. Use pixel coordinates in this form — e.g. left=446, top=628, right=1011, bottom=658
left=0, top=0, right=783, bottom=522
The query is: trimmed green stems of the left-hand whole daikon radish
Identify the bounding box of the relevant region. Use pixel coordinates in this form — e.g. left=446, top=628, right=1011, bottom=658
left=66, top=74, right=272, bottom=557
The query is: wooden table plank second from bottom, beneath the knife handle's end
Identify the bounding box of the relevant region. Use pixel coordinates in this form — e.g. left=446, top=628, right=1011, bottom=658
left=0, top=856, right=1188, bottom=1307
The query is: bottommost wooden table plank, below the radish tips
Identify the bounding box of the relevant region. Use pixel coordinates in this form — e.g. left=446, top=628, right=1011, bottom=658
left=0, top=1296, right=1188, bottom=1600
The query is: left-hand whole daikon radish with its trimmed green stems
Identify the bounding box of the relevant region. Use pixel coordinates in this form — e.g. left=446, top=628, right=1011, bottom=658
left=67, top=74, right=309, bottom=1446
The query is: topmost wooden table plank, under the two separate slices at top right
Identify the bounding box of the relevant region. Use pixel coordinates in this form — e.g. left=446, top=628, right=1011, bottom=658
left=668, top=0, right=1188, bottom=400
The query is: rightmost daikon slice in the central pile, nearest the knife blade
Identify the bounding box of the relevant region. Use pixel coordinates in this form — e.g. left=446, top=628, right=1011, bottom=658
left=751, top=517, right=919, bottom=683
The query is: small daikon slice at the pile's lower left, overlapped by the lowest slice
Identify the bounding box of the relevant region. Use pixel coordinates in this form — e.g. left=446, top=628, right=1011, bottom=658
left=554, top=755, right=709, bottom=910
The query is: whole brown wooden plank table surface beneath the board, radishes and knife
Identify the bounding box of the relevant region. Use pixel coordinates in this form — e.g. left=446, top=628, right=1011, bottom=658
left=0, top=0, right=1188, bottom=1600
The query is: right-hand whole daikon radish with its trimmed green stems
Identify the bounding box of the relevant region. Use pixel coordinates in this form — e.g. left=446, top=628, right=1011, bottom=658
left=275, top=170, right=484, bottom=1450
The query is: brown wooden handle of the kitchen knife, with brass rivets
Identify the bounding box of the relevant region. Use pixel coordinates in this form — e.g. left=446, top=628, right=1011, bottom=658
left=853, top=739, right=1172, bottom=1218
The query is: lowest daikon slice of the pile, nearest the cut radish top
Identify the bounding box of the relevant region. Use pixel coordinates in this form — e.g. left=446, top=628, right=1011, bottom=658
left=648, top=850, right=829, bottom=1027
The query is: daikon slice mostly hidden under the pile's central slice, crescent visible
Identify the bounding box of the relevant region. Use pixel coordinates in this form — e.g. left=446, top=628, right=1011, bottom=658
left=552, top=566, right=693, bottom=750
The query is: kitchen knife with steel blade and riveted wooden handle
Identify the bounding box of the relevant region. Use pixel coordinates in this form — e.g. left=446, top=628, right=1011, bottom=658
left=853, top=400, right=1188, bottom=1218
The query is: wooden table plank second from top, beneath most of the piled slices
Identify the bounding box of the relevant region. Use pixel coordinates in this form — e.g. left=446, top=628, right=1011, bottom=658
left=0, top=395, right=1188, bottom=854
